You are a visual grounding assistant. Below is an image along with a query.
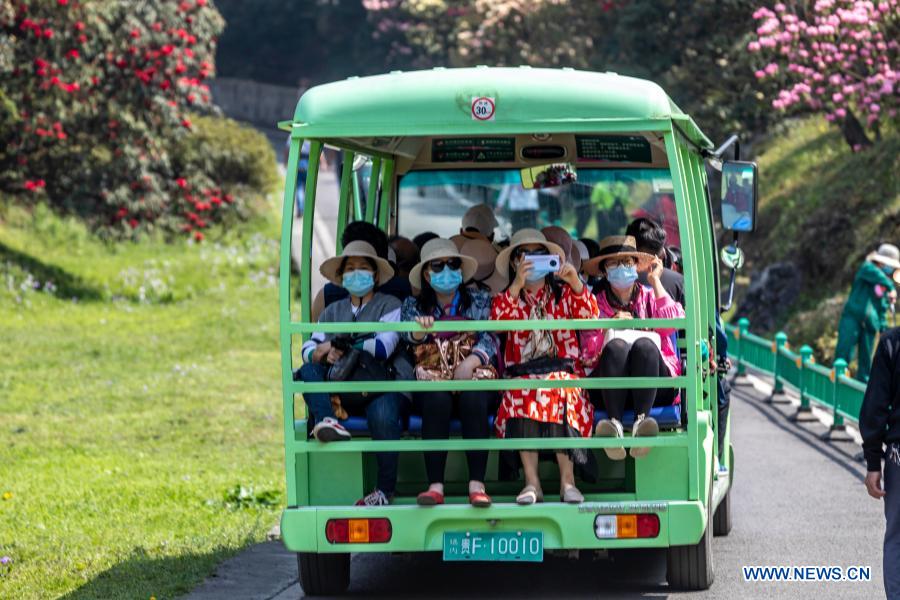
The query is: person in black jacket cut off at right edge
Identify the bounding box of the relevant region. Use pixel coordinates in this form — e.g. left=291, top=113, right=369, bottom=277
left=859, top=328, right=900, bottom=600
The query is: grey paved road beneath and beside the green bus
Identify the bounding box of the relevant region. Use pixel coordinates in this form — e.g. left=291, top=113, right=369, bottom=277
left=189, top=378, right=884, bottom=600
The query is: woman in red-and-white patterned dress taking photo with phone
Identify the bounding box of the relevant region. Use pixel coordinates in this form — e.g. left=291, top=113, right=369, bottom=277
left=491, top=229, right=598, bottom=504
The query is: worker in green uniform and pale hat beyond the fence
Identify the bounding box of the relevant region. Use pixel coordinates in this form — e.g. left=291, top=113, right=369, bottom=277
left=834, top=244, right=900, bottom=382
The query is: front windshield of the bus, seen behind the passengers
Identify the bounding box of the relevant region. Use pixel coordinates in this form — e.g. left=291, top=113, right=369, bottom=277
left=398, top=168, right=681, bottom=246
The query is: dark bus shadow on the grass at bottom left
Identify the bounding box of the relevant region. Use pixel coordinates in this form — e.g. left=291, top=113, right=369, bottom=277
left=60, top=548, right=240, bottom=600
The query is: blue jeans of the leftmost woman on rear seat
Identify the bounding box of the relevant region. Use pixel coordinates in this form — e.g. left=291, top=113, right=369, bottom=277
left=300, top=363, right=407, bottom=497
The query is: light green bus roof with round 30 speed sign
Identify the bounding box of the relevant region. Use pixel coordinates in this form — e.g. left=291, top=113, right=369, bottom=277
left=280, top=67, right=712, bottom=148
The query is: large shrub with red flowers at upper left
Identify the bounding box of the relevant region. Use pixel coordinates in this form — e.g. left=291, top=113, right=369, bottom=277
left=0, top=0, right=268, bottom=240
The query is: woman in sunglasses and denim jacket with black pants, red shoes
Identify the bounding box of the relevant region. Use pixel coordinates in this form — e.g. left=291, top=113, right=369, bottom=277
left=402, top=238, right=497, bottom=507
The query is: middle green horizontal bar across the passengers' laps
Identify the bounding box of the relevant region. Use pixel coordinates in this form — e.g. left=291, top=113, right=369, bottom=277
left=285, top=376, right=688, bottom=394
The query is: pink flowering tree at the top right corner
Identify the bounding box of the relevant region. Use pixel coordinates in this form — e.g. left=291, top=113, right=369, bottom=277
left=747, top=0, right=900, bottom=150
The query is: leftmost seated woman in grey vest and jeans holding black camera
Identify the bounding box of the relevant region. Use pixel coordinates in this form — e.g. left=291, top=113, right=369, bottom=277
left=299, top=241, right=412, bottom=506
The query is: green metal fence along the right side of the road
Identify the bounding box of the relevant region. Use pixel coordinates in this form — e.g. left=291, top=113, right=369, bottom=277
left=725, top=319, right=866, bottom=428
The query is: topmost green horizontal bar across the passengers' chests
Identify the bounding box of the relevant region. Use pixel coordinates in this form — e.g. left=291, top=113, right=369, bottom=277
left=286, top=318, right=687, bottom=333
